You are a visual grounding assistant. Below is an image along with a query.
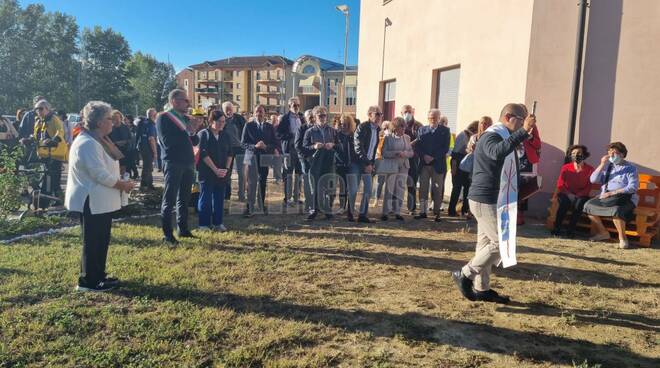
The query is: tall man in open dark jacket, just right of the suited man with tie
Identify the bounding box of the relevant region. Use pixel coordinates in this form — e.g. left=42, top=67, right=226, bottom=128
left=276, top=97, right=305, bottom=207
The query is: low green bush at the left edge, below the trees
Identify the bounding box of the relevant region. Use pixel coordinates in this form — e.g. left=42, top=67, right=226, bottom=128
left=0, top=147, right=26, bottom=221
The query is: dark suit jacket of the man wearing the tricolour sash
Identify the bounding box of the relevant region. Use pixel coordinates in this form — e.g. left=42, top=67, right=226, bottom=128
left=156, top=112, right=199, bottom=166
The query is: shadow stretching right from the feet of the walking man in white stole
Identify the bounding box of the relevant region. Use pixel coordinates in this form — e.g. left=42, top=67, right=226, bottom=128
left=497, top=302, right=660, bottom=333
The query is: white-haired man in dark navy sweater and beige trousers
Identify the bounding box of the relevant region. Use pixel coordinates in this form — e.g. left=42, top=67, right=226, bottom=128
left=415, top=109, right=451, bottom=222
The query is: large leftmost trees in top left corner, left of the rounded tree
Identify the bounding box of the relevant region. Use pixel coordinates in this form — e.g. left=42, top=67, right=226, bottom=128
left=0, top=0, right=79, bottom=113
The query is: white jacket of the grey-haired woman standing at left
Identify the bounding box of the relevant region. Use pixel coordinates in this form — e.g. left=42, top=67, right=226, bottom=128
left=64, top=133, right=121, bottom=215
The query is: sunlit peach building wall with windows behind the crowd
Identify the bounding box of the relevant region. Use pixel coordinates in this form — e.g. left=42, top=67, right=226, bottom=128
left=356, top=0, right=534, bottom=123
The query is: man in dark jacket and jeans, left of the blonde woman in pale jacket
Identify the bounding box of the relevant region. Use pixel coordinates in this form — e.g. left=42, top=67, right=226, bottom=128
left=353, top=106, right=383, bottom=223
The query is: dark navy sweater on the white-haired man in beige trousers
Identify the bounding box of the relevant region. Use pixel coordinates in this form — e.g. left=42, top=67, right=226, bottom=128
left=415, top=125, right=451, bottom=174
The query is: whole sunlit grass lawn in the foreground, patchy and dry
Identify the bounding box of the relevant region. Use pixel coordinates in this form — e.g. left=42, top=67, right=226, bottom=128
left=0, top=191, right=660, bottom=367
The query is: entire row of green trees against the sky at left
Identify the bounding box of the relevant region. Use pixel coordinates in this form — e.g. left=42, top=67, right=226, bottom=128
left=0, top=0, right=176, bottom=114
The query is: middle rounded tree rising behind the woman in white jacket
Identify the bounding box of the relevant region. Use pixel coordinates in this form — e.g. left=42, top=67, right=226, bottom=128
left=81, top=26, right=134, bottom=111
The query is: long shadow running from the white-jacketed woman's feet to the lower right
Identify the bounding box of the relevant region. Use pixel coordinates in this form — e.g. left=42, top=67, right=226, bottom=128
left=114, top=282, right=657, bottom=367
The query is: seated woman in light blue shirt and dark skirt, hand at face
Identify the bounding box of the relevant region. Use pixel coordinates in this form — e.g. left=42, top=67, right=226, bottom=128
left=584, top=142, right=639, bottom=249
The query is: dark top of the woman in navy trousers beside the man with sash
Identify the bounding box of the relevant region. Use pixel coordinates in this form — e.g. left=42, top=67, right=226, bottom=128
left=197, top=129, right=232, bottom=184
